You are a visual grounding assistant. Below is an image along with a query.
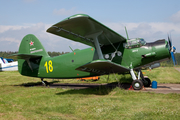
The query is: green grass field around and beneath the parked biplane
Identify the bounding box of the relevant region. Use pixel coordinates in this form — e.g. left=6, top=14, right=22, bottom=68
left=0, top=67, right=180, bottom=120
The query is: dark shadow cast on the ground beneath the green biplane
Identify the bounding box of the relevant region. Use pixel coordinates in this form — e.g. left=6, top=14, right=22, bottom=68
left=14, top=78, right=131, bottom=95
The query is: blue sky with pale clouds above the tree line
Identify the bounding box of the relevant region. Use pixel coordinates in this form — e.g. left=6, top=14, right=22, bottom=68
left=0, top=0, right=180, bottom=52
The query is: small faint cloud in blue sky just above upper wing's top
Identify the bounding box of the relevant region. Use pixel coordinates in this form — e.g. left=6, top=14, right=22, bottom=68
left=53, top=8, right=82, bottom=16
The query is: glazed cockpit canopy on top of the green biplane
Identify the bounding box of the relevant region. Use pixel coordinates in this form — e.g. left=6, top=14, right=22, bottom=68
left=124, top=38, right=146, bottom=49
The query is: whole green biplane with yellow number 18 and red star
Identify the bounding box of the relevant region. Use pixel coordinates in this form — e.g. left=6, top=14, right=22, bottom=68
left=16, top=14, right=175, bottom=90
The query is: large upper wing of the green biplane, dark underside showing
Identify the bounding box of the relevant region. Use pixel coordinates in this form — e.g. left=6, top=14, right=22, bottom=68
left=47, top=14, right=126, bottom=47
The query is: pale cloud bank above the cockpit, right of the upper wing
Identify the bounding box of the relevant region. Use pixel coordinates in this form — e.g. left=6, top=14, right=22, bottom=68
left=104, top=22, right=180, bottom=41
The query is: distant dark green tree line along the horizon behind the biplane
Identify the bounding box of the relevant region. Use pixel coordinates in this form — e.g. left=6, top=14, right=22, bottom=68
left=0, top=51, right=180, bottom=67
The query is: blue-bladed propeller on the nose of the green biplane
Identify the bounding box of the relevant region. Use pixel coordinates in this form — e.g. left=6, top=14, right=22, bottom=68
left=168, top=35, right=177, bottom=66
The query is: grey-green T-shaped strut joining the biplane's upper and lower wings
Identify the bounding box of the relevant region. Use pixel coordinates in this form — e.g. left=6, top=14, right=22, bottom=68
left=86, top=31, right=104, bottom=59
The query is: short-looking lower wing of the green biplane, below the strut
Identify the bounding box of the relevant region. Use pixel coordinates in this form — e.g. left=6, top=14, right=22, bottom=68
left=76, top=60, right=129, bottom=75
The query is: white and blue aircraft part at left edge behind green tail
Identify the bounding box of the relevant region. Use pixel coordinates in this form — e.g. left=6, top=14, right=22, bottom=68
left=0, top=57, right=18, bottom=72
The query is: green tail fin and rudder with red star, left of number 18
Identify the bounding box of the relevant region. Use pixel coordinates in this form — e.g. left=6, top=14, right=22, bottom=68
left=17, top=34, right=49, bottom=77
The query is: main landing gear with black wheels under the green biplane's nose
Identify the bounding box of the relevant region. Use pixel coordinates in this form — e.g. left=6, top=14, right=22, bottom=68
left=130, top=69, right=151, bottom=90
